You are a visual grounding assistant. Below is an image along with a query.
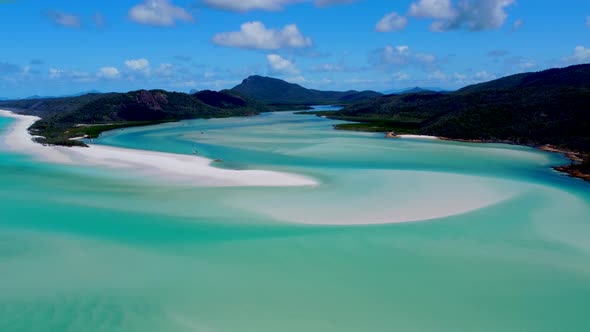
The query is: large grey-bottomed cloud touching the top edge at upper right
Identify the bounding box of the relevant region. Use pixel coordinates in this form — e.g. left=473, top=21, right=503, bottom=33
left=409, top=0, right=515, bottom=32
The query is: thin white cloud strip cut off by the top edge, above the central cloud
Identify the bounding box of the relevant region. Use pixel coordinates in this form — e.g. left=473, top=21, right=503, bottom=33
left=204, top=0, right=356, bottom=12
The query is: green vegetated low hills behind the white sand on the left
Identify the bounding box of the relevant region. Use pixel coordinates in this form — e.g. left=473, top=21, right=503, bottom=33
left=0, top=90, right=268, bottom=146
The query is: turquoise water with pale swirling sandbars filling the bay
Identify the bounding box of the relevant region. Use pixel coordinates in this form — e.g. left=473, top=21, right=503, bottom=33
left=0, top=113, right=590, bottom=332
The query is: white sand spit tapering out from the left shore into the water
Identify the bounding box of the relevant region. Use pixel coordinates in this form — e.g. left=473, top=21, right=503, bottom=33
left=0, top=110, right=318, bottom=187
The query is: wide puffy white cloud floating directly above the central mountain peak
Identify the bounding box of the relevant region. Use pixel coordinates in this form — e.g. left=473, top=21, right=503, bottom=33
left=213, top=21, right=313, bottom=50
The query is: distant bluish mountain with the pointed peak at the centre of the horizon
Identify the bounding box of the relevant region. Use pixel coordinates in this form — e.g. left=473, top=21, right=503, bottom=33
left=231, top=76, right=382, bottom=105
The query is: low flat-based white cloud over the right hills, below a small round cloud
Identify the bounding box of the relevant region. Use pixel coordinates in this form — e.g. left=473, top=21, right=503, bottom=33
left=371, top=45, right=436, bottom=67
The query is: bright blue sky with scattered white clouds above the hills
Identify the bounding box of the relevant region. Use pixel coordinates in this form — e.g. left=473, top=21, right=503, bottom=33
left=0, top=0, right=590, bottom=98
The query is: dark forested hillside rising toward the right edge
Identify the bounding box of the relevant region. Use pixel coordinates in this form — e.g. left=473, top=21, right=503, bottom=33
left=329, top=65, right=590, bottom=152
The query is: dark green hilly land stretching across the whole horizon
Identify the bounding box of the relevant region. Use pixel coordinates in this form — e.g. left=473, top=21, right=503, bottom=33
left=0, top=65, right=590, bottom=180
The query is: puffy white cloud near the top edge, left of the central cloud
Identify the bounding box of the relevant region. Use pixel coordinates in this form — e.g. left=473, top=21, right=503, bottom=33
left=129, top=0, right=193, bottom=26
